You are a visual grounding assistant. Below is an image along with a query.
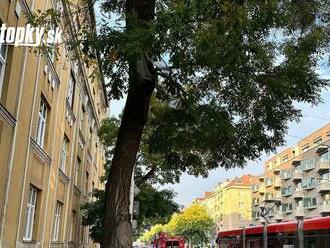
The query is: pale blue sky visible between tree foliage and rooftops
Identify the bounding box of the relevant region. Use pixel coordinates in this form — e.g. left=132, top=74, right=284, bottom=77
left=110, top=65, right=330, bottom=206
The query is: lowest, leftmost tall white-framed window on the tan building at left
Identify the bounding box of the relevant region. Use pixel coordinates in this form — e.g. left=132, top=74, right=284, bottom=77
left=23, top=187, right=38, bottom=241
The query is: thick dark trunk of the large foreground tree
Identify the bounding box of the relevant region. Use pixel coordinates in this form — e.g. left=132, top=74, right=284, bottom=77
left=102, top=0, right=156, bottom=248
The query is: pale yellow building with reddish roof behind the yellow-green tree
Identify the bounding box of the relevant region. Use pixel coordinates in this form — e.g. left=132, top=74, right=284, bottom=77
left=193, top=175, right=256, bottom=231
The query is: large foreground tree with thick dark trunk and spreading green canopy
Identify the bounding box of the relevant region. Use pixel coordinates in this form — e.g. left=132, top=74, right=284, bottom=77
left=27, top=0, right=330, bottom=248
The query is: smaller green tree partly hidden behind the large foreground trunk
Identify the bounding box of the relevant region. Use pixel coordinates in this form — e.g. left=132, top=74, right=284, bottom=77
left=81, top=118, right=179, bottom=243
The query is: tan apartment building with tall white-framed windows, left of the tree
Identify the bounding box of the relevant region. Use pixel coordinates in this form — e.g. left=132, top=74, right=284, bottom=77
left=0, top=0, right=108, bottom=248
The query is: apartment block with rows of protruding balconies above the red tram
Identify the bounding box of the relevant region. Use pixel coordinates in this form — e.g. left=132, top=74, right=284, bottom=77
left=252, top=124, right=330, bottom=224
